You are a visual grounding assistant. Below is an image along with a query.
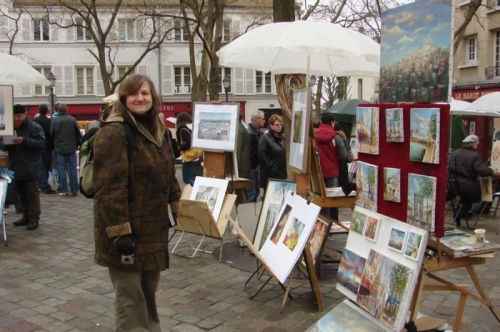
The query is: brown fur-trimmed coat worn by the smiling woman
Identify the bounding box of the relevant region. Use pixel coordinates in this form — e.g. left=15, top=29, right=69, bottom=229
left=93, top=102, right=181, bottom=271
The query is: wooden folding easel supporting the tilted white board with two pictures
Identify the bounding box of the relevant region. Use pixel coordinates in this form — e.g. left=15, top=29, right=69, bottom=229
left=229, top=218, right=325, bottom=312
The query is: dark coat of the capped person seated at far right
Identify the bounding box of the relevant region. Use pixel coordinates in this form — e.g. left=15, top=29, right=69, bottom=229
left=448, top=148, right=493, bottom=202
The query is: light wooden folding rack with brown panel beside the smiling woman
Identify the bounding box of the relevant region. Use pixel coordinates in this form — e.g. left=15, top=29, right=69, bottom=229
left=171, top=185, right=236, bottom=262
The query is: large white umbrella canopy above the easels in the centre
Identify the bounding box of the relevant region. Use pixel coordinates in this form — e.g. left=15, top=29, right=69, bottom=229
left=217, top=21, right=380, bottom=77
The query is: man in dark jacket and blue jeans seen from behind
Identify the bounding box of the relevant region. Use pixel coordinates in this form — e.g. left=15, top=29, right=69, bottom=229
left=50, top=104, right=82, bottom=196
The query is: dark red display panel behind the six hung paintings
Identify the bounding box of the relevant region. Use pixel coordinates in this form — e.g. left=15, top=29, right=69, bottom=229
left=358, top=104, right=450, bottom=237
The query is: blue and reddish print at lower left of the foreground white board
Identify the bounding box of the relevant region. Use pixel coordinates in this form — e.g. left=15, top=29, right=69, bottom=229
left=337, top=249, right=366, bottom=296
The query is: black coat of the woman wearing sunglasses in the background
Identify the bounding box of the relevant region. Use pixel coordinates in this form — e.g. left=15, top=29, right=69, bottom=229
left=259, top=131, right=286, bottom=189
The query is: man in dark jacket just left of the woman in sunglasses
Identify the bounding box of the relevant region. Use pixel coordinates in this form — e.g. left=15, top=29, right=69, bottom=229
left=246, top=111, right=266, bottom=202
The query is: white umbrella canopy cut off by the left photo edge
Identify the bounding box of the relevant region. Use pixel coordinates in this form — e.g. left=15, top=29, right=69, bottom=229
left=0, top=53, right=50, bottom=86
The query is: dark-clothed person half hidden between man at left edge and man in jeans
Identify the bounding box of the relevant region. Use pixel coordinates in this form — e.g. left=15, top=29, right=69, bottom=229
left=33, top=104, right=56, bottom=194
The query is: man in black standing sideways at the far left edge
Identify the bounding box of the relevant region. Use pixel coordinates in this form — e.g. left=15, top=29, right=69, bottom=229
left=0, top=105, right=45, bottom=230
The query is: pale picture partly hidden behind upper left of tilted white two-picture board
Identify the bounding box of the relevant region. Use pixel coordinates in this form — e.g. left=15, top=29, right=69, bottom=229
left=253, top=180, right=297, bottom=250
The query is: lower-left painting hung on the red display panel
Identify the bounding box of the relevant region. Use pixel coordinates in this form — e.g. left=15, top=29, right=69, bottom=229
left=356, top=161, right=378, bottom=211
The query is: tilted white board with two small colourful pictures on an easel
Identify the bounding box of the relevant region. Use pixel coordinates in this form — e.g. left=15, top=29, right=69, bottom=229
left=259, top=194, right=320, bottom=284
